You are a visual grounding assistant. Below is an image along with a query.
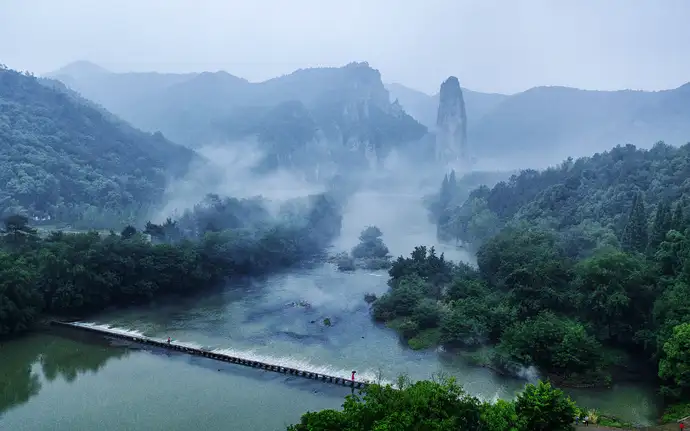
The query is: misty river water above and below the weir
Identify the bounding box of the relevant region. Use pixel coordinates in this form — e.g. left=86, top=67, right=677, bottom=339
left=0, top=193, right=657, bottom=431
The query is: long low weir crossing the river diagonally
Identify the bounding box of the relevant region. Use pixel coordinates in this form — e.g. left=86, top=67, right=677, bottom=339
left=51, top=321, right=369, bottom=389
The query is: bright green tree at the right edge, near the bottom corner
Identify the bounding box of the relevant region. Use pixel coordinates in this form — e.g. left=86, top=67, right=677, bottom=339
left=659, top=323, right=690, bottom=398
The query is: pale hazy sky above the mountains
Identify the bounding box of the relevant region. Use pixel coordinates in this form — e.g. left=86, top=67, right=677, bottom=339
left=0, top=0, right=690, bottom=93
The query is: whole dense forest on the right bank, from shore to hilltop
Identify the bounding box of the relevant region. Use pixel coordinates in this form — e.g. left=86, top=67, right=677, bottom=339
left=373, top=144, right=690, bottom=416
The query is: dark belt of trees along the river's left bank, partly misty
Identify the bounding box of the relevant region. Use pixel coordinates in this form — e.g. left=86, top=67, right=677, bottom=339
left=0, top=195, right=342, bottom=337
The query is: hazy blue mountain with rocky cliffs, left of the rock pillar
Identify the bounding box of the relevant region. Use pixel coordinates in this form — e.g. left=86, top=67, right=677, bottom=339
left=50, top=63, right=427, bottom=177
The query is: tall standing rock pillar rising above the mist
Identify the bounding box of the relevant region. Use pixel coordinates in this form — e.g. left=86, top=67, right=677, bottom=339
left=435, top=76, right=470, bottom=170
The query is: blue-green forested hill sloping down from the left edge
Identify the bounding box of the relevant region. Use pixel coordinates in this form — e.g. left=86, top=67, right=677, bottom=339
left=0, top=69, right=198, bottom=226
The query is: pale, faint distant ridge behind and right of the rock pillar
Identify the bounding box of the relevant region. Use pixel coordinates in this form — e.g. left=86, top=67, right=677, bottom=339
left=388, top=84, right=690, bottom=168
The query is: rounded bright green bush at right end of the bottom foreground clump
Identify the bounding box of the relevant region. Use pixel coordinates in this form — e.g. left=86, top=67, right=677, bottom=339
left=515, top=382, right=577, bottom=431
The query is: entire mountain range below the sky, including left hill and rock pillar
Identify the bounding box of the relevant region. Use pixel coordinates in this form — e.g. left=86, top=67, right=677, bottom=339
left=0, top=62, right=690, bottom=230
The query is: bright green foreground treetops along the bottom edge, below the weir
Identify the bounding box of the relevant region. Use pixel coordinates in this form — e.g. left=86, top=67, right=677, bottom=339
left=288, top=378, right=577, bottom=431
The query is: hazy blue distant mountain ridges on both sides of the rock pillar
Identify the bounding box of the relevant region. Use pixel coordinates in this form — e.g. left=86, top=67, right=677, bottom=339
left=51, top=63, right=690, bottom=172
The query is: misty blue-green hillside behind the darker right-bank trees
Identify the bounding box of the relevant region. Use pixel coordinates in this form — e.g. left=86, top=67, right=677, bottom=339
left=436, top=143, right=690, bottom=250
